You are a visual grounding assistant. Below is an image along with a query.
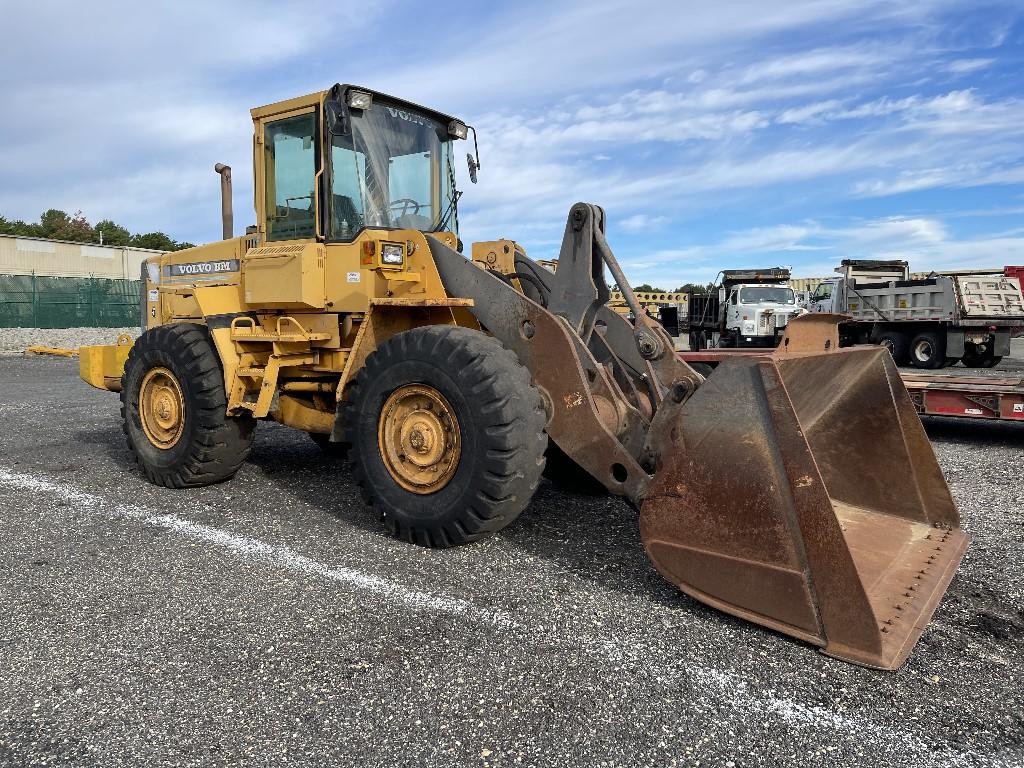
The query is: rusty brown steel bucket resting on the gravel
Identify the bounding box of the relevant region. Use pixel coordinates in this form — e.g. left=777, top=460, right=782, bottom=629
left=641, top=315, right=969, bottom=670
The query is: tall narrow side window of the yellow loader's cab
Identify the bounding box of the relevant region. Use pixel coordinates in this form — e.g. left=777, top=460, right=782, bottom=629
left=263, top=113, right=316, bottom=240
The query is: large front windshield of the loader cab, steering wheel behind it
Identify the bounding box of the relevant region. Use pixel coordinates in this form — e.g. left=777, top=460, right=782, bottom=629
left=330, top=101, right=458, bottom=240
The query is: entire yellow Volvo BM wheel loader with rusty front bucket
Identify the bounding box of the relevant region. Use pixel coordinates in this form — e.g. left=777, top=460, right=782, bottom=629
left=80, top=85, right=968, bottom=669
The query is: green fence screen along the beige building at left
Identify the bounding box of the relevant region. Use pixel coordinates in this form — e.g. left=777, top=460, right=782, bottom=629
left=0, top=274, right=141, bottom=328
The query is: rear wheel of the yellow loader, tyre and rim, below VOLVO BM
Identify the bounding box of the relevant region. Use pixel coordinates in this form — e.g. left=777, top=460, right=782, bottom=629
left=121, top=323, right=256, bottom=488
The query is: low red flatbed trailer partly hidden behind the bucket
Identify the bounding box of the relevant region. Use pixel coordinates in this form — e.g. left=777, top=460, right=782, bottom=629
left=678, top=349, right=1024, bottom=422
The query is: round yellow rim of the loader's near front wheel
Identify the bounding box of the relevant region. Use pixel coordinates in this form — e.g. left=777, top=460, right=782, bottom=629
left=377, top=384, right=462, bottom=494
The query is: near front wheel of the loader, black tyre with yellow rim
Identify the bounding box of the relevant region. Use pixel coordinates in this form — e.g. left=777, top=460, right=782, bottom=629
left=343, top=326, right=548, bottom=547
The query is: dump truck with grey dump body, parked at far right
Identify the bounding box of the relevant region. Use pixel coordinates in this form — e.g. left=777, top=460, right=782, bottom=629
left=807, top=259, right=1024, bottom=369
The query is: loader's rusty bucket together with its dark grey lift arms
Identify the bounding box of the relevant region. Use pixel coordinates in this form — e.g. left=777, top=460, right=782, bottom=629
left=430, top=203, right=968, bottom=669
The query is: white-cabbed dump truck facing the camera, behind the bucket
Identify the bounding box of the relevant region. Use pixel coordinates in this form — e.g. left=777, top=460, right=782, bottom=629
left=687, top=267, right=807, bottom=349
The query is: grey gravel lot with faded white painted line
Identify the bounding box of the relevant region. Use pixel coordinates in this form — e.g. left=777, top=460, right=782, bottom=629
left=0, top=358, right=1024, bottom=768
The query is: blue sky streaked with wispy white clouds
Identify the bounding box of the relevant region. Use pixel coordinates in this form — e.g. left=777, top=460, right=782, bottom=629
left=0, top=0, right=1024, bottom=288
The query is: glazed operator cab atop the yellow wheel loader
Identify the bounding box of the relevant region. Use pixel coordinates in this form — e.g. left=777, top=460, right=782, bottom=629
left=252, top=85, right=468, bottom=249
